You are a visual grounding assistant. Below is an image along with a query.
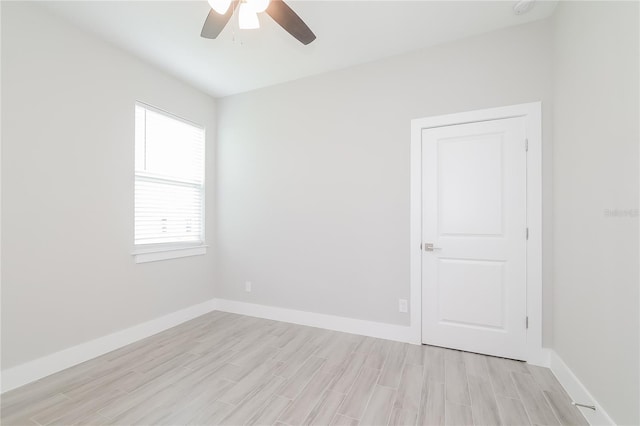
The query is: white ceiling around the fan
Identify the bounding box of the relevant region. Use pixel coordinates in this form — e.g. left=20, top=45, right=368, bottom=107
left=41, top=0, right=557, bottom=97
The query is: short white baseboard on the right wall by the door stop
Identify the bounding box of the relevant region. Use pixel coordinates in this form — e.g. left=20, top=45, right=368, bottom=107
left=550, top=350, right=615, bottom=426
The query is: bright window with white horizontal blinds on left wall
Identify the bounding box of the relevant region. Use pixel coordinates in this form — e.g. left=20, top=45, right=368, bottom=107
left=134, top=103, right=206, bottom=263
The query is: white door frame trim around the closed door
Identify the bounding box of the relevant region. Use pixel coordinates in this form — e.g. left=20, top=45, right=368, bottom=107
left=409, top=102, right=549, bottom=366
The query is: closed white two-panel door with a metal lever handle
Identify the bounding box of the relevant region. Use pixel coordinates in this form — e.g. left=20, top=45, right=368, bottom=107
left=422, top=117, right=527, bottom=360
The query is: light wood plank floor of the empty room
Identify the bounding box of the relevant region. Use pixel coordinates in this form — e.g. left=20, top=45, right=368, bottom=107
left=2, top=312, right=586, bottom=426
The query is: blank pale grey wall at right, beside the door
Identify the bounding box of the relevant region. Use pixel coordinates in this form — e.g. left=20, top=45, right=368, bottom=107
left=553, top=2, right=640, bottom=425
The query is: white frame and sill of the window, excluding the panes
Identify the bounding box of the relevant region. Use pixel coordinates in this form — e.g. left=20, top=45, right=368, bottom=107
left=131, top=101, right=209, bottom=263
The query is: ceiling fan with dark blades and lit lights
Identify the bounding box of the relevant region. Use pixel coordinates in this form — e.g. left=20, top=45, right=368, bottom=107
left=200, top=0, right=316, bottom=45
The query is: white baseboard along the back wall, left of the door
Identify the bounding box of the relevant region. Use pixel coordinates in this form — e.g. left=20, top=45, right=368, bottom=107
left=215, top=299, right=420, bottom=344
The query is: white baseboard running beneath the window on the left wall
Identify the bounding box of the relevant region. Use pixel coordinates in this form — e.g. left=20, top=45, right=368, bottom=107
left=0, top=300, right=215, bottom=392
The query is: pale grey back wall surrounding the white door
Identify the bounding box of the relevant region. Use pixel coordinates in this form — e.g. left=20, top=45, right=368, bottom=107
left=216, top=21, right=552, bottom=336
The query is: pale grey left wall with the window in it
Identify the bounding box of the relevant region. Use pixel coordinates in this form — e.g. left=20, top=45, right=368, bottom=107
left=2, top=2, right=216, bottom=369
